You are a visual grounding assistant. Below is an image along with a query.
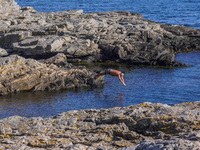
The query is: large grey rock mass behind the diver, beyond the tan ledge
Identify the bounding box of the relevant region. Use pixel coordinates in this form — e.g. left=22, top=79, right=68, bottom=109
left=0, top=0, right=200, bottom=66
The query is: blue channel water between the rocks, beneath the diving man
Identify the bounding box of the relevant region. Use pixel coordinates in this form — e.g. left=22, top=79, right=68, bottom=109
left=0, top=52, right=200, bottom=118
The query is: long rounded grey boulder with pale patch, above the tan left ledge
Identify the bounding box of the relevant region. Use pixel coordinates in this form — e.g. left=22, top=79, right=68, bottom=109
left=12, top=36, right=100, bottom=62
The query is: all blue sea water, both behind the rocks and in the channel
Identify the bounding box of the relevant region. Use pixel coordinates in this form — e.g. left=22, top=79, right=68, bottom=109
left=0, top=0, right=200, bottom=118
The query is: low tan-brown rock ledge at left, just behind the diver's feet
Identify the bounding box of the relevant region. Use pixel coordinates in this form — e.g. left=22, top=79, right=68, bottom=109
left=0, top=54, right=103, bottom=95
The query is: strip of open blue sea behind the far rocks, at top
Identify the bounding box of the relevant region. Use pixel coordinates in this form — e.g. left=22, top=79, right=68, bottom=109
left=16, top=0, right=200, bottom=28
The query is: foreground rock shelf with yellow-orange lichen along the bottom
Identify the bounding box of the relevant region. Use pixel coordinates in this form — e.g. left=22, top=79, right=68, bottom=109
left=0, top=102, right=200, bottom=150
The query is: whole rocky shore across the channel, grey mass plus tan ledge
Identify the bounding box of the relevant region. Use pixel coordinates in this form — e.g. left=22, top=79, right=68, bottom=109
left=0, top=0, right=200, bottom=95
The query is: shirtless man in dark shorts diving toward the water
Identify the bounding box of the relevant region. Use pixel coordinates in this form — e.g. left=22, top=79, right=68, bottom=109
left=94, top=69, right=126, bottom=86
